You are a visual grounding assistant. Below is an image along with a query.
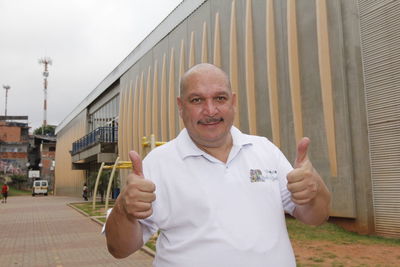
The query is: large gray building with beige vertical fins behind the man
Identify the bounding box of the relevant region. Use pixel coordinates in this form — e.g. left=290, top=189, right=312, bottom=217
left=55, top=0, right=400, bottom=237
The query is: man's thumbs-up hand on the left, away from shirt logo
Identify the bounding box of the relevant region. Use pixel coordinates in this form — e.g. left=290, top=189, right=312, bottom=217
left=119, top=151, right=156, bottom=221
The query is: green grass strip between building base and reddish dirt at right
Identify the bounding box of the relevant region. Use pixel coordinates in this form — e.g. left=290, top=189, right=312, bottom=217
left=286, top=218, right=400, bottom=246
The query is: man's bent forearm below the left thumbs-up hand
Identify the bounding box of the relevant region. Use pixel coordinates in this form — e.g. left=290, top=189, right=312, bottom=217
left=106, top=200, right=143, bottom=258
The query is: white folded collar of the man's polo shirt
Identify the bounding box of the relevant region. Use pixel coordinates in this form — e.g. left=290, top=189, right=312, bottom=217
left=176, top=126, right=252, bottom=159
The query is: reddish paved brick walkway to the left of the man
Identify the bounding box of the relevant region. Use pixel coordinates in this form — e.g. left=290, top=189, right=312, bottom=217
left=0, top=196, right=153, bottom=267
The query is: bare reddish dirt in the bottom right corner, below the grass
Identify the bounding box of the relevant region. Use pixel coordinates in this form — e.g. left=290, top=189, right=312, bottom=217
left=292, top=241, right=400, bottom=267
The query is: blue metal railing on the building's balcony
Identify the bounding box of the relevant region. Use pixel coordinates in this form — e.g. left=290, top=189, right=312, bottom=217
left=71, top=126, right=118, bottom=155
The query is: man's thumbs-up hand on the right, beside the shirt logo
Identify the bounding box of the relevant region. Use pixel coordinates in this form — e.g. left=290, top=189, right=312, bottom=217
left=287, top=137, right=323, bottom=205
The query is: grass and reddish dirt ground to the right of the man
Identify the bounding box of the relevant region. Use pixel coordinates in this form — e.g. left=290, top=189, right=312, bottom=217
left=286, top=218, right=400, bottom=267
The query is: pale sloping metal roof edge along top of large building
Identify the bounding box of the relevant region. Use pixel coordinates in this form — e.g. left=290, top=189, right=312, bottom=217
left=55, top=0, right=207, bottom=134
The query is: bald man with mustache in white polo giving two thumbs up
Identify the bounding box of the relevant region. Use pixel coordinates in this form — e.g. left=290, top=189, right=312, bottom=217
left=106, top=64, right=330, bottom=267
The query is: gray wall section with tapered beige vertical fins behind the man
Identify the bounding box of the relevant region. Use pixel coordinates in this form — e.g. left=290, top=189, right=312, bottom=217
left=115, top=0, right=357, bottom=218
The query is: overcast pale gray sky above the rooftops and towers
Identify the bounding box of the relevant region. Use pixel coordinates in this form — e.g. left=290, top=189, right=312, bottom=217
left=0, top=0, right=181, bottom=130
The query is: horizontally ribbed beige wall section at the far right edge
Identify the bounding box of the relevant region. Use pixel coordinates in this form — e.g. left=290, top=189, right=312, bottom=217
left=359, top=0, right=400, bottom=237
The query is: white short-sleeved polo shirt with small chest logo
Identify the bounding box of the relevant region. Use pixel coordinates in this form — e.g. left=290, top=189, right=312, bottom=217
left=141, top=127, right=296, bottom=267
